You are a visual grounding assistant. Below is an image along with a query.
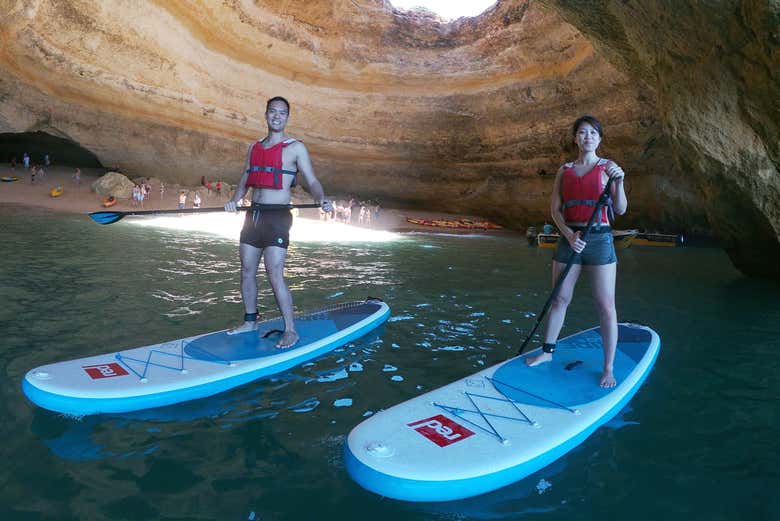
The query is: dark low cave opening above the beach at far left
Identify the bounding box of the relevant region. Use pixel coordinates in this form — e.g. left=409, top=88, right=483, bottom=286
left=0, top=132, right=103, bottom=168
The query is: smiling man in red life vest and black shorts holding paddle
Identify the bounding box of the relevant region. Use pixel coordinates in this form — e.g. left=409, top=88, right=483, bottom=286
left=225, top=96, right=332, bottom=348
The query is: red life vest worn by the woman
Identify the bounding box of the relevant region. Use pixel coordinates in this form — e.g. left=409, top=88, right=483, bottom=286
left=561, top=159, right=609, bottom=224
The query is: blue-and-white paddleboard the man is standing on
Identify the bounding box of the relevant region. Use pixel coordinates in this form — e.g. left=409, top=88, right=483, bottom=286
left=22, top=298, right=390, bottom=416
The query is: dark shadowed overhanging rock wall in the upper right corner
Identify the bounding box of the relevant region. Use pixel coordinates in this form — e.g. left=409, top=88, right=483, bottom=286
left=545, top=0, right=780, bottom=278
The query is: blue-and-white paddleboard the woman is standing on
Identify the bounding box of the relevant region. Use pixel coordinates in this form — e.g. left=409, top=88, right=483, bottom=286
left=344, top=323, right=661, bottom=501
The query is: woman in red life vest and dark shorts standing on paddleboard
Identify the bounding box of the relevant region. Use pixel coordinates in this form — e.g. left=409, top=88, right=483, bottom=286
left=526, top=116, right=628, bottom=387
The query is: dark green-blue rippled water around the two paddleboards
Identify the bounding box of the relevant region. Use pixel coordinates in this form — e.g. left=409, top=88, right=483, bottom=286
left=0, top=207, right=780, bottom=521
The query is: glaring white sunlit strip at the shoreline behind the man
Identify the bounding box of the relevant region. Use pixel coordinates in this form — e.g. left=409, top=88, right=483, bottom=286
left=129, top=212, right=403, bottom=243
